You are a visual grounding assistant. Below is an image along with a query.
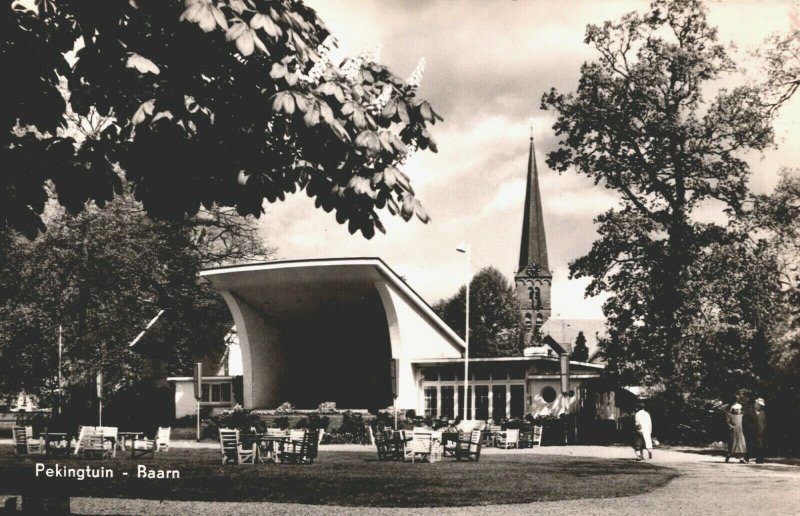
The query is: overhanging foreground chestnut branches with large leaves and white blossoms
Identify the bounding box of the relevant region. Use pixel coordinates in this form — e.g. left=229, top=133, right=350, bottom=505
left=0, top=0, right=440, bottom=238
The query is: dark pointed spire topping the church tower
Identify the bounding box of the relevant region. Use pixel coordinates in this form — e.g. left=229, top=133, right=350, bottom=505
left=518, top=132, right=550, bottom=276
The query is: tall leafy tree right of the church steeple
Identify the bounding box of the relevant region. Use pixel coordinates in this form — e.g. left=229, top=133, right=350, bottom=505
left=542, top=0, right=773, bottom=391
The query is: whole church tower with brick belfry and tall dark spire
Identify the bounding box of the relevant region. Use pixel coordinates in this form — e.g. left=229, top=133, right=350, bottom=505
left=514, top=134, right=553, bottom=346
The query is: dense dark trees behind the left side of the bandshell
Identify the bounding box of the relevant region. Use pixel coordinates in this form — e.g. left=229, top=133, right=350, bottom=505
left=0, top=194, right=271, bottom=408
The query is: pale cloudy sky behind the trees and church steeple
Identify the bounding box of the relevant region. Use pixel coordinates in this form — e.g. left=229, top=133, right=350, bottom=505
left=261, top=0, right=800, bottom=318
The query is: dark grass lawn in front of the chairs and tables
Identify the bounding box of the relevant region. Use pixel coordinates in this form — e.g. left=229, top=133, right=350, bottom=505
left=0, top=446, right=677, bottom=507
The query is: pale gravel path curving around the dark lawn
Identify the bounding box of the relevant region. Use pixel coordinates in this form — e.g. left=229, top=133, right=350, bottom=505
left=56, top=441, right=800, bottom=516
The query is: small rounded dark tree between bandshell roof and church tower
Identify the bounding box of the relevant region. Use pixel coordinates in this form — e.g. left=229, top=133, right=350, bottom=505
left=433, top=267, right=522, bottom=357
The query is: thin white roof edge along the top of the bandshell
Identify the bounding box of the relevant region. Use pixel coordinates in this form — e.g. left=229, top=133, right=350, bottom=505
left=200, top=257, right=466, bottom=352
